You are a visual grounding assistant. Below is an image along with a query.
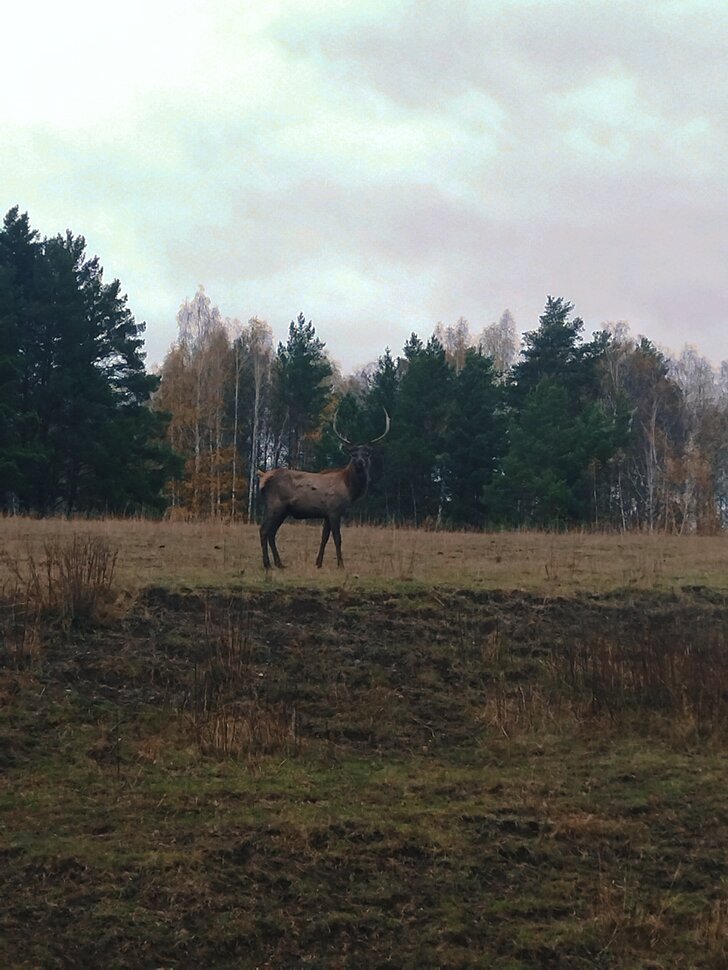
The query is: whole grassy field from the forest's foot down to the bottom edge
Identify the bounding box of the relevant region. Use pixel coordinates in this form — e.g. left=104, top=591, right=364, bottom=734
left=0, top=519, right=728, bottom=968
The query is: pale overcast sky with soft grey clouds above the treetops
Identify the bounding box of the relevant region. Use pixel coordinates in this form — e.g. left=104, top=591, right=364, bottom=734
left=0, top=0, right=728, bottom=371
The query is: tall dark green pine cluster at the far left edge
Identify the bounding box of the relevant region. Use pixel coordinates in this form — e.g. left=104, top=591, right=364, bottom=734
left=0, top=208, right=174, bottom=513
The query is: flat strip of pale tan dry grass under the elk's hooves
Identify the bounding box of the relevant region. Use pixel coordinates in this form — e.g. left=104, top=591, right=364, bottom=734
left=0, top=518, right=728, bottom=595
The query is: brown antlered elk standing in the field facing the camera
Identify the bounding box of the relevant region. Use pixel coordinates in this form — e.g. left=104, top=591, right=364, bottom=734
left=258, top=409, right=390, bottom=569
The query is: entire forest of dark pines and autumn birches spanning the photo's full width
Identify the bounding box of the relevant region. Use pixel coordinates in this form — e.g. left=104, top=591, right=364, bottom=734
left=0, top=208, right=728, bottom=533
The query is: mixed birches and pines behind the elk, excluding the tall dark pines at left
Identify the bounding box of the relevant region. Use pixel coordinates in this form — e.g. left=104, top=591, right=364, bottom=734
left=155, top=288, right=728, bottom=532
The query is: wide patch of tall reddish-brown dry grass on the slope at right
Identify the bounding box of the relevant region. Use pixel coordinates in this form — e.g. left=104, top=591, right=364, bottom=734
left=477, top=614, right=728, bottom=741
